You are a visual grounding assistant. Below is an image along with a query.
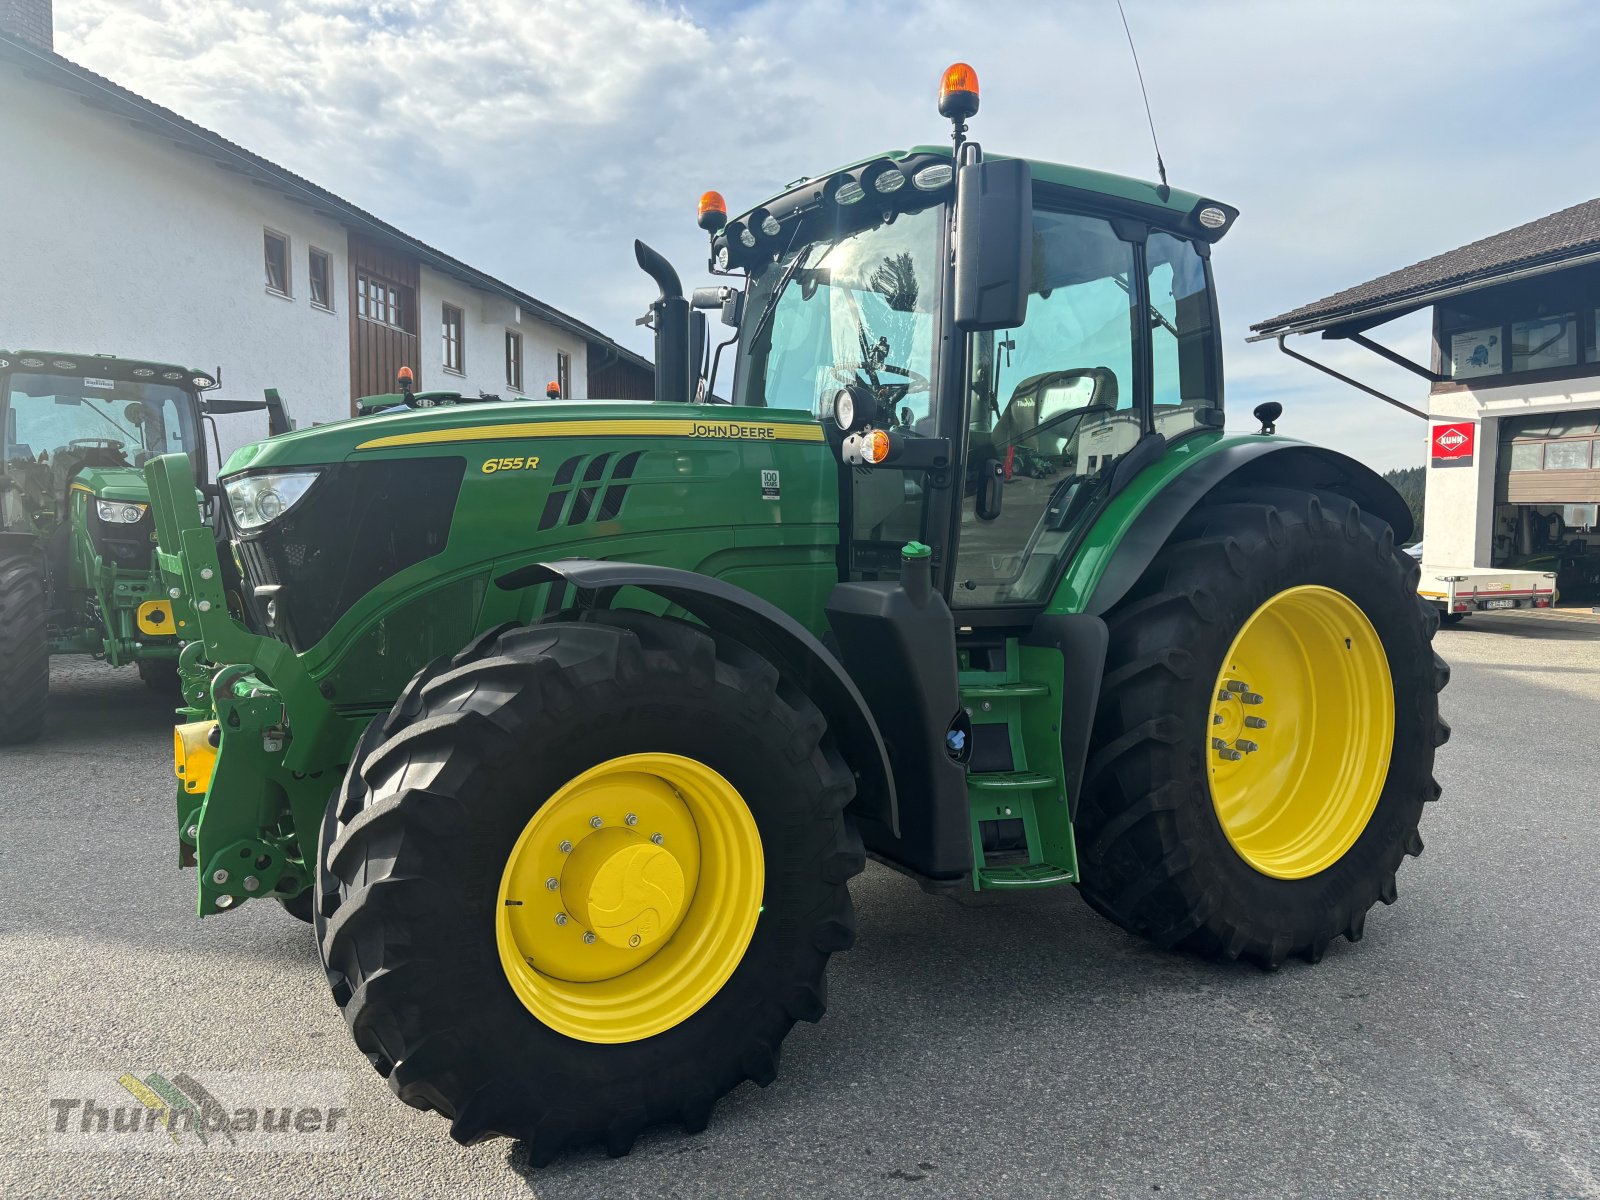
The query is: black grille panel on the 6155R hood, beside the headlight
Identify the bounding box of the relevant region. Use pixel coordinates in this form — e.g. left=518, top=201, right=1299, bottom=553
left=238, top=458, right=466, bottom=650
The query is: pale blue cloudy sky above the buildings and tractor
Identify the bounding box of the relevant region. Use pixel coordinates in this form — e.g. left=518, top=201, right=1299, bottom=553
left=56, top=0, right=1600, bottom=467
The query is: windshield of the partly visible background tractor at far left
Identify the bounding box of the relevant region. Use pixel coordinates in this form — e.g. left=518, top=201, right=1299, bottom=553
left=3, top=373, right=198, bottom=467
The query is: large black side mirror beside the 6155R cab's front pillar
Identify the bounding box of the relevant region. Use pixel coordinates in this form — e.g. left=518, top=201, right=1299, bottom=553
left=955, top=158, right=1034, bottom=333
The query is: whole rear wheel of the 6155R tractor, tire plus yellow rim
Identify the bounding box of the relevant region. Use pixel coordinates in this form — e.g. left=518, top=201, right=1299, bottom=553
left=1077, top=490, right=1450, bottom=966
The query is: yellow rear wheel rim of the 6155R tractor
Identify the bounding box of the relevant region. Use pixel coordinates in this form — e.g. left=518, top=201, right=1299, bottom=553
left=1206, top=587, right=1395, bottom=878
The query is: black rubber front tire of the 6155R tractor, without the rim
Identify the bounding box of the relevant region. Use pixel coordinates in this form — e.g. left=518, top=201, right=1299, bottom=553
left=317, top=613, right=864, bottom=1165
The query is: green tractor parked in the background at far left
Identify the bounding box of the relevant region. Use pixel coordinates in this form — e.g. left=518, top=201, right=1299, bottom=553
left=0, top=350, right=291, bottom=746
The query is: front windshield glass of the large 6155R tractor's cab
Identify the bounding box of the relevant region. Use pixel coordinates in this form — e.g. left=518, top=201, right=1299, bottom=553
left=734, top=206, right=944, bottom=437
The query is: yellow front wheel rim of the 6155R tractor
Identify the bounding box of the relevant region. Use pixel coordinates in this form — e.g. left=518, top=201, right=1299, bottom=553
left=494, top=754, right=766, bottom=1042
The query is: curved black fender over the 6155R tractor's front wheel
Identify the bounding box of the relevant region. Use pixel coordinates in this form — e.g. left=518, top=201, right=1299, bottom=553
left=494, top=558, right=899, bottom=835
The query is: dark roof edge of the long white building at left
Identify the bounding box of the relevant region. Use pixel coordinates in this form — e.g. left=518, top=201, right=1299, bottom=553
left=0, top=34, right=651, bottom=368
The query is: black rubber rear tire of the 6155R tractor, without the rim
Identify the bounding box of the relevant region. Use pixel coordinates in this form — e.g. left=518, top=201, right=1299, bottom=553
left=1077, top=488, right=1450, bottom=968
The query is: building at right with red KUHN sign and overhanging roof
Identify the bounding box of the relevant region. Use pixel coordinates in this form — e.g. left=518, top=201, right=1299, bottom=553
left=1251, top=200, right=1600, bottom=602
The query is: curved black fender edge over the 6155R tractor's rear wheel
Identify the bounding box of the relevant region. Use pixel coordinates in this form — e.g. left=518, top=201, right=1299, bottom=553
left=1083, top=448, right=1411, bottom=616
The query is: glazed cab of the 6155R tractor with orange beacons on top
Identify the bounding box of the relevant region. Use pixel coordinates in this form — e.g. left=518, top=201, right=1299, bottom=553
left=696, top=68, right=1237, bottom=626
